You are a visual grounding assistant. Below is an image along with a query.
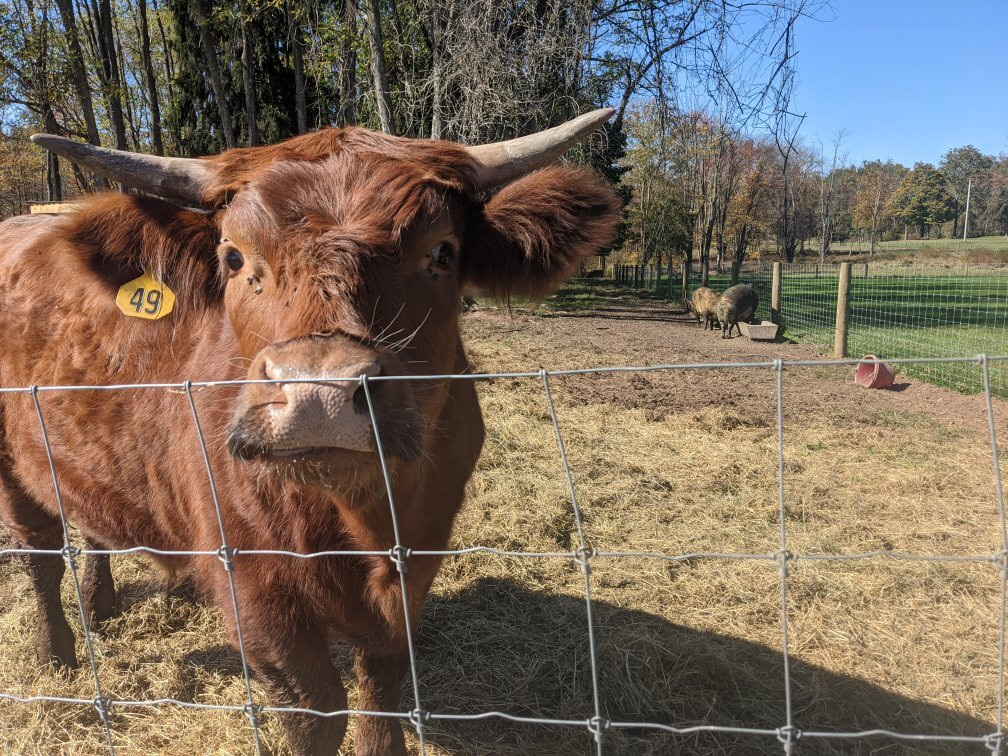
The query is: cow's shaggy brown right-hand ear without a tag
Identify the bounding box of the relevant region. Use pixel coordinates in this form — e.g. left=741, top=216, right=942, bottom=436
left=462, top=166, right=620, bottom=301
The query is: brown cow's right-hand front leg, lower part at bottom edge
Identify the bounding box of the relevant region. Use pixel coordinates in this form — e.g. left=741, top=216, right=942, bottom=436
left=354, top=647, right=409, bottom=756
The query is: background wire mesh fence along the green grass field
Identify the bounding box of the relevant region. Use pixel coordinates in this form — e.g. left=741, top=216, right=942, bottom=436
left=669, top=262, right=1008, bottom=398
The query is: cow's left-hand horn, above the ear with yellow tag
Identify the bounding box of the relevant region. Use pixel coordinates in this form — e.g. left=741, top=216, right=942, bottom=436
left=31, top=134, right=211, bottom=208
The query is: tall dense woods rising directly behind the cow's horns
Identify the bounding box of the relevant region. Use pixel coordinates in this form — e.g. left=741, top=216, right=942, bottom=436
left=0, top=0, right=823, bottom=224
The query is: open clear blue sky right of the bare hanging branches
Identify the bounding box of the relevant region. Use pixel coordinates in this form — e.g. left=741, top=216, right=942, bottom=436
left=792, top=0, right=1008, bottom=165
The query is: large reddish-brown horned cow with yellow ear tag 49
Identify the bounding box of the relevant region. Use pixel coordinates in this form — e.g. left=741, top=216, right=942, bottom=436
left=0, top=111, right=619, bottom=754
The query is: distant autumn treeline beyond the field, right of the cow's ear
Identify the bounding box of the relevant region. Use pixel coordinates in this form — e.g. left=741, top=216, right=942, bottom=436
left=620, top=99, right=1008, bottom=280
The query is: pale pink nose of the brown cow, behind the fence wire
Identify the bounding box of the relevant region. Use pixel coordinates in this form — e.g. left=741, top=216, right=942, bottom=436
left=263, top=357, right=381, bottom=454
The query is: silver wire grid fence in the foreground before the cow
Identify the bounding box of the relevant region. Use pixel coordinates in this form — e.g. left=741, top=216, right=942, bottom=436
left=0, top=354, right=1008, bottom=756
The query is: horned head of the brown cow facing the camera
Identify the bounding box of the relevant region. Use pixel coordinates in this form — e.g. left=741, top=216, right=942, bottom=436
left=33, top=111, right=619, bottom=485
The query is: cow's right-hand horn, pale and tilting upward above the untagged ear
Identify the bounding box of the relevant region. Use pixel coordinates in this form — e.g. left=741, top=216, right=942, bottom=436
left=468, top=108, right=616, bottom=188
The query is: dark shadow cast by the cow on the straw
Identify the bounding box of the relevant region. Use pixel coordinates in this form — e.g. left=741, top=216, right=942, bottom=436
left=157, top=565, right=995, bottom=756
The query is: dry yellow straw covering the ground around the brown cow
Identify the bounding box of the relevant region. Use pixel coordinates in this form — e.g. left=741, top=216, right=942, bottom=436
left=0, top=286, right=1008, bottom=756
